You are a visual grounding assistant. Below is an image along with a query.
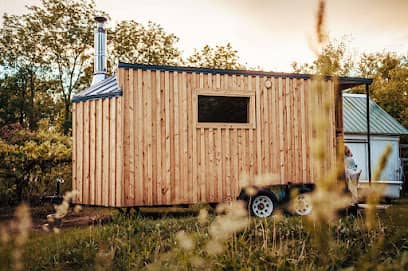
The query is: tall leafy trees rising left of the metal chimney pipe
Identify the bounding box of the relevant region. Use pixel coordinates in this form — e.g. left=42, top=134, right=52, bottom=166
left=0, top=0, right=101, bottom=134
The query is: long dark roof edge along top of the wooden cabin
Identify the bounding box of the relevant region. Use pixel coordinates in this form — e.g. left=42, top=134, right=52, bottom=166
left=118, top=62, right=373, bottom=84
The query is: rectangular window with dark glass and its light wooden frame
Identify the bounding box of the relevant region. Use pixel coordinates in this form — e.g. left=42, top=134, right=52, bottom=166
left=195, top=90, right=255, bottom=128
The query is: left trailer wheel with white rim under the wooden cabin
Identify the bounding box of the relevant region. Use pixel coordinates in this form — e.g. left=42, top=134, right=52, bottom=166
left=249, top=190, right=277, bottom=217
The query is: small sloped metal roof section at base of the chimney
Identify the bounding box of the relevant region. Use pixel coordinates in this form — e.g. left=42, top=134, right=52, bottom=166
left=72, top=76, right=122, bottom=102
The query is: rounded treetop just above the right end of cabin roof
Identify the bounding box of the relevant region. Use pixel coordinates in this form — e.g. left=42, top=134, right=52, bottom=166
left=292, top=38, right=355, bottom=76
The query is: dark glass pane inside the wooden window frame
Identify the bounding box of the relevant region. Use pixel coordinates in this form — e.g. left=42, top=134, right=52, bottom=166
left=198, top=95, right=249, bottom=123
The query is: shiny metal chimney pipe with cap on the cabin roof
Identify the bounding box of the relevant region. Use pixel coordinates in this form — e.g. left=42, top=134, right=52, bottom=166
left=92, top=16, right=107, bottom=85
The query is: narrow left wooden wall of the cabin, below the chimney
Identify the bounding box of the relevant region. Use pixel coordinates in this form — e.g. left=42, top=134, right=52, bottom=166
left=72, top=97, right=124, bottom=206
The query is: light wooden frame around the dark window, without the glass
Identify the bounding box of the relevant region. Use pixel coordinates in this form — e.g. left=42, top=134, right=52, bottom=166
left=193, top=89, right=256, bottom=129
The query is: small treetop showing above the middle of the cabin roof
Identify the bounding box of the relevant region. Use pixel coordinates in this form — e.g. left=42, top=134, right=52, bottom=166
left=187, top=43, right=244, bottom=70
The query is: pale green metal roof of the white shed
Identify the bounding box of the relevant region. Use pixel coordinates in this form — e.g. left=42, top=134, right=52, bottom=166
left=343, top=93, right=408, bottom=135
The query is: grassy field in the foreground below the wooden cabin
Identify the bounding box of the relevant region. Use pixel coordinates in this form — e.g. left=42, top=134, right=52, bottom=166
left=0, top=198, right=408, bottom=270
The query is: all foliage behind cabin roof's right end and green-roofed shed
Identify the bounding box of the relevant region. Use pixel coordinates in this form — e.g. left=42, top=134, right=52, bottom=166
left=292, top=40, right=408, bottom=131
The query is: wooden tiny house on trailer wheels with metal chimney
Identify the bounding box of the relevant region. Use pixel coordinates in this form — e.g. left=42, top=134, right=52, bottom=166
left=72, top=17, right=371, bottom=216
